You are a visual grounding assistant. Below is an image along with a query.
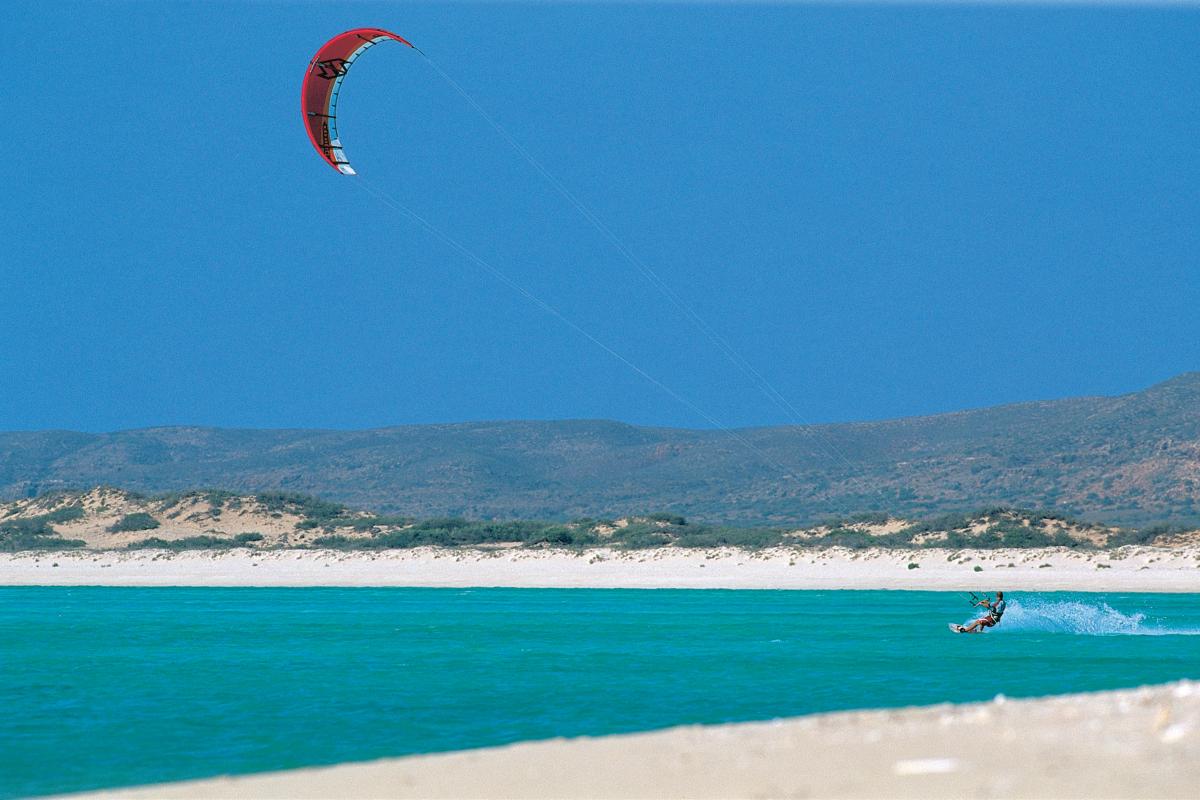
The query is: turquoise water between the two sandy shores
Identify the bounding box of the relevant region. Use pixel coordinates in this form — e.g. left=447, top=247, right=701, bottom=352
left=7, top=588, right=1200, bottom=798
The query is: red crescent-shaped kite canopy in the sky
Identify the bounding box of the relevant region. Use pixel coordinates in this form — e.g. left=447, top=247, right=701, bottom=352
left=300, top=28, right=416, bottom=175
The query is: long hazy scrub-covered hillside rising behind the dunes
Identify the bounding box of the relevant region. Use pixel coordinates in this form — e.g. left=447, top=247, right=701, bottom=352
left=0, top=373, right=1200, bottom=525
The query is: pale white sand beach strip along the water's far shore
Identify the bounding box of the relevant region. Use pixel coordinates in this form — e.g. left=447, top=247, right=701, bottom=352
left=0, top=547, right=1200, bottom=591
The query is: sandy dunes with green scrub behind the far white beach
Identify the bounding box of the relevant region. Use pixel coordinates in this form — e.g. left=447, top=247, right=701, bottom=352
left=0, top=488, right=1200, bottom=554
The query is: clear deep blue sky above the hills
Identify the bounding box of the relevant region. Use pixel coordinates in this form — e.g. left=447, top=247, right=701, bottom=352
left=0, top=2, right=1200, bottom=431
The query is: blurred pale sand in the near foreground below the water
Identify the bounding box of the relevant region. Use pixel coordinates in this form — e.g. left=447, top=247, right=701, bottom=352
left=63, top=682, right=1200, bottom=800
